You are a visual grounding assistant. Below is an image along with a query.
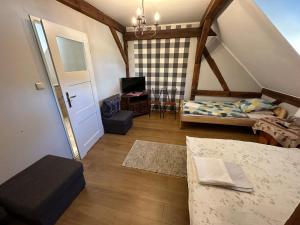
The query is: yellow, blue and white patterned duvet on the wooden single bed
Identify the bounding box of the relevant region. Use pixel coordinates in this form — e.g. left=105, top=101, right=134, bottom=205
left=183, top=101, right=248, bottom=118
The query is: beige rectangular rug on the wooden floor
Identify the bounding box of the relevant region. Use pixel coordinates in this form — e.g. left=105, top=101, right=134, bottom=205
left=123, top=140, right=186, bottom=177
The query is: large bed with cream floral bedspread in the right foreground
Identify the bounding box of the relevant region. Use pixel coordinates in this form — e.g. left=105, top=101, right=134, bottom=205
left=187, top=137, right=300, bottom=225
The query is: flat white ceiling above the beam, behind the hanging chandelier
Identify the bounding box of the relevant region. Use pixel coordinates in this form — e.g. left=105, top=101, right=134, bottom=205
left=86, top=0, right=210, bottom=26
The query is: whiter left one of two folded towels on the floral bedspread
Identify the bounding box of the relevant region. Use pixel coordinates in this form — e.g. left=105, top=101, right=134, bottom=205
left=193, top=156, right=234, bottom=186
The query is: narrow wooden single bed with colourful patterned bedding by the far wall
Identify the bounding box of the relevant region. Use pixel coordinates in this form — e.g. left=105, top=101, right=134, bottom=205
left=180, top=100, right=280, bottom=128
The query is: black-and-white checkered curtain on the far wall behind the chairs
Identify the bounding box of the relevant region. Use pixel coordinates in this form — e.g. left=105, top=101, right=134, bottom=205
left=134, top=38, right=190, bottom=101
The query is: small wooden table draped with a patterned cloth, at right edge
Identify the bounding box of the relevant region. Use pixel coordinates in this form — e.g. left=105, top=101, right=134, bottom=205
left=252, top=117, right=300, bottom=148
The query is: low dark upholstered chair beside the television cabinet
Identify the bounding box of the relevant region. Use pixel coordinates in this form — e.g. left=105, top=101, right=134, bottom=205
left=101, top=95, right=133, bottom=134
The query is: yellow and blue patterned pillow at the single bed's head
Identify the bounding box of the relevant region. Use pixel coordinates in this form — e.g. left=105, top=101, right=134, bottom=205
left=240, top=98, right=276, bottom=113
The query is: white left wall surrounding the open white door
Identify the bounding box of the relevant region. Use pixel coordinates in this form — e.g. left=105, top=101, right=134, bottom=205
left=0, top=0, right=125, bottom=183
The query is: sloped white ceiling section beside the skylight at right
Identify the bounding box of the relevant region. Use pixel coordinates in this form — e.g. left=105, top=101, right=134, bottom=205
left=216, top=0, right=300, bottom=97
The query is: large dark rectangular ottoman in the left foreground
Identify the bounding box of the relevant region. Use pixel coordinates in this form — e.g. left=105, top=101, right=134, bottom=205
left=0, top=155, right=85, bottom=225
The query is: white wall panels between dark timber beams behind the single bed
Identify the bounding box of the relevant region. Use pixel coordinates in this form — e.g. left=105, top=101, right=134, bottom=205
left=185, top=37, right=261, bottom=100
